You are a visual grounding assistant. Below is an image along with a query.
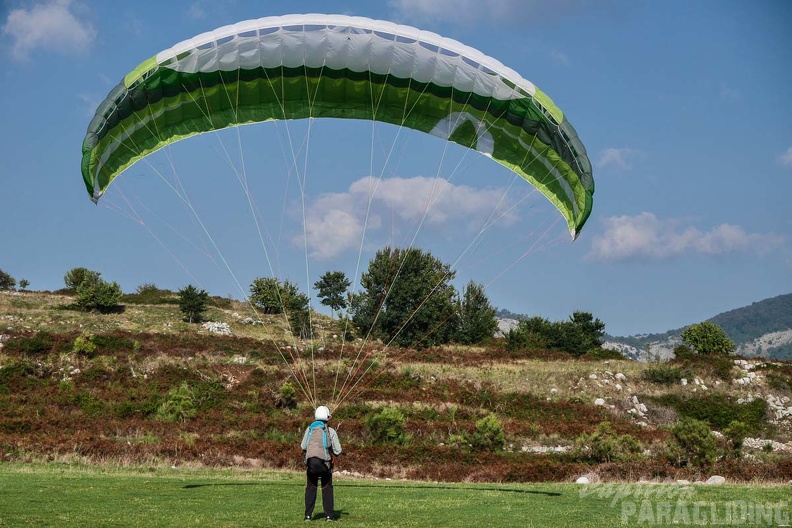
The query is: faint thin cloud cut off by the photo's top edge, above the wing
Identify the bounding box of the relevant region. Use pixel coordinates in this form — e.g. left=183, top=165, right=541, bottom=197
left=389, top=0, right=608, bottom=24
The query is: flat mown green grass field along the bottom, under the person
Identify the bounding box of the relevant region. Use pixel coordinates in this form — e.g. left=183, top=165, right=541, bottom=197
left=0, top=463, right=791, bottom=528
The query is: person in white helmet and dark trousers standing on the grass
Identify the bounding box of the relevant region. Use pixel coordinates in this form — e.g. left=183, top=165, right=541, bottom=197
left=300, top=405, right=342, bottom=521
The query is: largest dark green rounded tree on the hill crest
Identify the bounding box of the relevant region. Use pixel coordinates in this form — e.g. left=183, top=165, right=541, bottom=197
left=349, top=247, right=456, bottom=348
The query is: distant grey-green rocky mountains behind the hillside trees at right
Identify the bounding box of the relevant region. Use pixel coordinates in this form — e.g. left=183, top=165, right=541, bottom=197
left=496, top=293, right=792, bottom=361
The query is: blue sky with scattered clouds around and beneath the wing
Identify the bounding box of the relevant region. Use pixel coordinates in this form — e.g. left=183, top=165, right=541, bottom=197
left=0, top=0, right=792, bottom=335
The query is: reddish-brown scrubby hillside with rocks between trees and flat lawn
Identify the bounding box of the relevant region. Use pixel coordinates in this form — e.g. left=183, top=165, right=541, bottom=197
left=0, top=292, right=792, bottom=482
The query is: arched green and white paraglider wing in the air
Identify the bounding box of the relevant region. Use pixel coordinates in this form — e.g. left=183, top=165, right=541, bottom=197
left=82, top=14, right=594, bottom=237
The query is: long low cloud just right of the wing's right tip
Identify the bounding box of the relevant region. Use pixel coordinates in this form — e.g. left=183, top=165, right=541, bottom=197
left=588, top=212, right=785, bottom=261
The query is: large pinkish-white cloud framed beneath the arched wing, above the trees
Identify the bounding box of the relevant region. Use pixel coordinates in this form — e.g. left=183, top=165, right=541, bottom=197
left=293, top=176, right=517, bottom=258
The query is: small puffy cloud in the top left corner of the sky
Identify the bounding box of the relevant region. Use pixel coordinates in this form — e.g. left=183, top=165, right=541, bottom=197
left=2, top=0, right=96, bottom=60
